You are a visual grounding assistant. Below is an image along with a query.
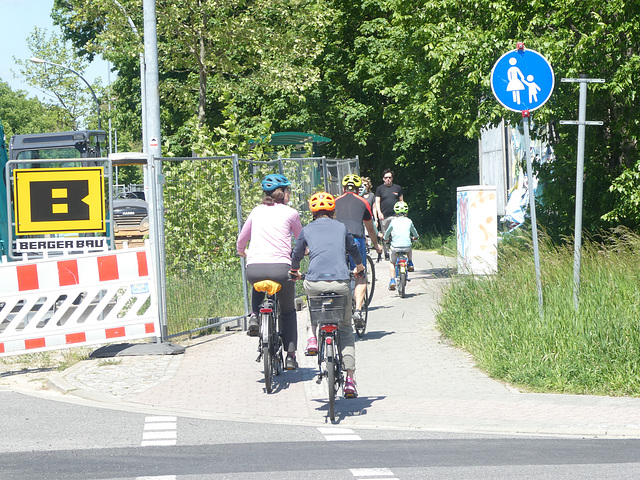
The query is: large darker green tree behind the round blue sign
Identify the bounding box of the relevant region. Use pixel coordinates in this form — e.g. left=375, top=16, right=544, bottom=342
left=294, top=0, right=640, bottom=233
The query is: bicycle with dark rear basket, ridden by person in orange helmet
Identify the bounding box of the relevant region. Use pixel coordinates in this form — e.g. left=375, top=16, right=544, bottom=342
left=307, top=293, right=347, bottom=421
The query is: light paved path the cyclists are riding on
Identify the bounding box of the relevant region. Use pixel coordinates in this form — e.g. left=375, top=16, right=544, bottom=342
left=16, top=252, right=640, bottom=438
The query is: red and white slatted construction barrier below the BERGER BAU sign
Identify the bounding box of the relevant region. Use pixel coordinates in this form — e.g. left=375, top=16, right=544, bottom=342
left=0, top=247, right=160, bottom=357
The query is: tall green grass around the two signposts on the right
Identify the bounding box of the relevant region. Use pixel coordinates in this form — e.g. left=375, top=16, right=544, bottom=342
left=437, top=231, right=640, bottom=396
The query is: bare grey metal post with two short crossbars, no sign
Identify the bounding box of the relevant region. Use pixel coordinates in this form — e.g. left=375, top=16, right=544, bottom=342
left=560, top=75, right=604, bottom=311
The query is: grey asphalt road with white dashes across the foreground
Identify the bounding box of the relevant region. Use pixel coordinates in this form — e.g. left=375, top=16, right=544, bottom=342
left=0, top=391, right=640, bottom=480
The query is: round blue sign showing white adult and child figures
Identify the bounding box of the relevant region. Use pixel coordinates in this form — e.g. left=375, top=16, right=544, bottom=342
left=491, top=49, right=555, bottom=112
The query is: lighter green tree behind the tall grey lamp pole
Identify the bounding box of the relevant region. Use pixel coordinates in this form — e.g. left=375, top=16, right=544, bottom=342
left=53, top=0, right=330, bottom=156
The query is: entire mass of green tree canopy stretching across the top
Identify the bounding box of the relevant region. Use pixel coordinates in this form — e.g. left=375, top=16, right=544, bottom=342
left=41, top=0, right=640, bottom=238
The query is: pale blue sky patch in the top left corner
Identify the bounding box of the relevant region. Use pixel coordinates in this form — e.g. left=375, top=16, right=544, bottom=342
left=0, top=0, right=115, bottom=100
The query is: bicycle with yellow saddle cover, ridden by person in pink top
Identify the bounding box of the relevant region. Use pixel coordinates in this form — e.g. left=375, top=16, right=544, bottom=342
left=253, top=280, right=284, bottom=393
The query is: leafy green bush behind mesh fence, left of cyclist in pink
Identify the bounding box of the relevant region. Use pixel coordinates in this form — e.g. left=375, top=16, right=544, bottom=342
left=164, top=106, right=270, bottom=273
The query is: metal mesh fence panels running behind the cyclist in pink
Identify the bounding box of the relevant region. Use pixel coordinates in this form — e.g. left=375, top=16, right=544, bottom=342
left=162, top=156, right=359, bottom=337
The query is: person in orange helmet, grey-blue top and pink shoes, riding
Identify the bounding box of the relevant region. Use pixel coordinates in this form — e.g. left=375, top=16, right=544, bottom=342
left=289, top=192, right=364, bottom=398
